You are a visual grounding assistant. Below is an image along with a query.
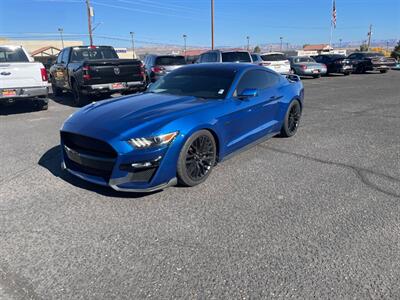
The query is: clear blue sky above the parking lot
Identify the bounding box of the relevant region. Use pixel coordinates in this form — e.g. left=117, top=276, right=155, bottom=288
left=0, top=0, right=400, bottom=47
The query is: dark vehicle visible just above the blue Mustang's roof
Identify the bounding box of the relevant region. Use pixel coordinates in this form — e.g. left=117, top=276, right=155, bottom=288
left=198, top=50, right=253, bottom=63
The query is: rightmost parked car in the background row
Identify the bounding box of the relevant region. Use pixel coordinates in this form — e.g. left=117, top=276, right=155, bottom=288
left=347, top=52, right=396, bottom=73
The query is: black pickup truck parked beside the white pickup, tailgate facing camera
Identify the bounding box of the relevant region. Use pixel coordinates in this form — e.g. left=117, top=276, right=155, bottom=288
left=50, top=46, right=146, bottom=106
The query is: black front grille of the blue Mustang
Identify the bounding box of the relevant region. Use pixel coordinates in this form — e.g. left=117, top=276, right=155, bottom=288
left=61, top=132, right=117, bottom=181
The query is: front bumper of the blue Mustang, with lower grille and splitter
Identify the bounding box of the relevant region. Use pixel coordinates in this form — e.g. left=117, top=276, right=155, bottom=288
left=61, top=133, right=180, bottom=193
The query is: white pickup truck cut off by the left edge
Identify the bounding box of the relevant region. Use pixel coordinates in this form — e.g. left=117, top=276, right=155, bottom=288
left=0, top=45, right=49, bottom=110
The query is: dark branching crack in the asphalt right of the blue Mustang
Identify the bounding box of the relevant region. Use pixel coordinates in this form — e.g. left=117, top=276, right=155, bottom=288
left=258, top=144, right=400, bottom=198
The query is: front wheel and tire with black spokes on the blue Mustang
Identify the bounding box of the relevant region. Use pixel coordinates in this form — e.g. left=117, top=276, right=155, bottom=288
left=177, top=130, right=217, bottom=186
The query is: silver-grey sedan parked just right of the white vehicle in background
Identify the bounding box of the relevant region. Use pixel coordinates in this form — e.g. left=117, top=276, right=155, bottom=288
left=289, top=56, right=327, bottom=78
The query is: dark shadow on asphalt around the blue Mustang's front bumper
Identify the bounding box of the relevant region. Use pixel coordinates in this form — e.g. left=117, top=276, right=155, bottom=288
left=38, top=145, right=158, bottom=198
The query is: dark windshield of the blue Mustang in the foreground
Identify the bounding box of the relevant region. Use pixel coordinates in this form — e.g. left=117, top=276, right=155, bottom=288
left=148, top=68, right=236, bottom=99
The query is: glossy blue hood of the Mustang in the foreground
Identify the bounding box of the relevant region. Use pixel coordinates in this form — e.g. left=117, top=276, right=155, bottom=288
left=64, top=93, right=219, bottom=138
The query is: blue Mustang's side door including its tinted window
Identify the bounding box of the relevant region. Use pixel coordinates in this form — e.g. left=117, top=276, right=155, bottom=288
left=226, top=70, right=282, bottom=152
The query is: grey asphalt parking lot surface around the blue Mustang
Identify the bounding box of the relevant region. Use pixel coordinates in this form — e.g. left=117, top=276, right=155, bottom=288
left=0, top=71, right=400, bottom=299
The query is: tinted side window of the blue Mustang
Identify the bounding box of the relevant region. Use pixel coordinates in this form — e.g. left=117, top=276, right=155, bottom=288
left=236, top=70, right=279, bottom=95
